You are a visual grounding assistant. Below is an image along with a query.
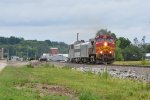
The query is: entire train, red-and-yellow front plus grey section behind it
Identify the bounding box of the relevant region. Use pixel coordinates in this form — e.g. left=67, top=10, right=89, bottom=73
left=69, top=35, right=115, bottom=63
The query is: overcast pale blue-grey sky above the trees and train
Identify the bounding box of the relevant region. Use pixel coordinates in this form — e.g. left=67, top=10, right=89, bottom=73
left=0, top=0, right=150, bottom=44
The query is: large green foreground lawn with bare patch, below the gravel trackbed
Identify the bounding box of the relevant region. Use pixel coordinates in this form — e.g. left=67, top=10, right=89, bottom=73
left=0, top=65, right=150, bottom=100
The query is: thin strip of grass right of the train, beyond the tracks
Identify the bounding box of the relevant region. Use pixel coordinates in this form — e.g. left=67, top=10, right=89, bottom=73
left=113, top=60, right=150, bottom=66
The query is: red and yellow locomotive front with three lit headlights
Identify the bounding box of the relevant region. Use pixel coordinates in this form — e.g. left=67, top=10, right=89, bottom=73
left=95, top=35, right=115, bottom=62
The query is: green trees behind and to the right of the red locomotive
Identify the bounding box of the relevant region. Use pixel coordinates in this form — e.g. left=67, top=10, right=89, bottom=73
left=96, top=29, right=150, bottom=61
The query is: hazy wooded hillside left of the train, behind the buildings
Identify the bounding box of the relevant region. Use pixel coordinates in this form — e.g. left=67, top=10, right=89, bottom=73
left=0, top=36, right=68, bottom=59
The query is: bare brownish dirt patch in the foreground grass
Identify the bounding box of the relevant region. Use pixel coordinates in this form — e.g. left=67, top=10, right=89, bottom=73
left=16, top=83, right=77, bottom=100
